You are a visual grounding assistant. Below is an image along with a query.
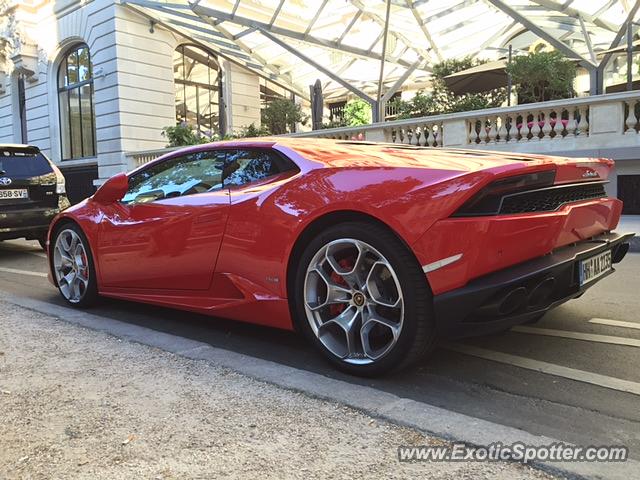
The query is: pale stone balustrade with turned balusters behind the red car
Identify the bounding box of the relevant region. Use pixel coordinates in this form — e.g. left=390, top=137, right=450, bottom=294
left=126, top=91, right=640, bottom=168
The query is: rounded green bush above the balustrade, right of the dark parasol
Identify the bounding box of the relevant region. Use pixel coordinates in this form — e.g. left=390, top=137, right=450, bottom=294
left=507, top=50, right=576, bottom=103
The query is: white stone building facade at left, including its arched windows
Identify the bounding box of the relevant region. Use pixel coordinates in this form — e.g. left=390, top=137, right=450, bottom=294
left=0, top=0, right=264, bottom=200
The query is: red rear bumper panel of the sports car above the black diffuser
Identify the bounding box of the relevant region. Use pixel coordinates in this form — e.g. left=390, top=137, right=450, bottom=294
left=412, top=198, right=622, bottom=295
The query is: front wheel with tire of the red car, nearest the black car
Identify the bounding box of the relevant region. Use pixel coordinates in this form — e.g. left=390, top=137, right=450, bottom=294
left=51, top=223, right=98, bottom=308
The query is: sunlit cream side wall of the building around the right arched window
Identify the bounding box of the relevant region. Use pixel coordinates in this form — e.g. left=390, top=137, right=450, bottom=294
left=114, top=6, right=260, bottom=159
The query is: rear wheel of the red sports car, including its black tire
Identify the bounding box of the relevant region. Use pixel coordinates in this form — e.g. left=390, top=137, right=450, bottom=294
left=292, top=222, right=435, bottom=376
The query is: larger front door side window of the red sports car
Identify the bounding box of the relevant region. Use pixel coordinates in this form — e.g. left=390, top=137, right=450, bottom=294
left=122, top=151, right=226, bottom=203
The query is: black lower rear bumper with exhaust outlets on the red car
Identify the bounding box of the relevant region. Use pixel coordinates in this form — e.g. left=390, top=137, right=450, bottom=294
left=434, top=233, right=633, bottom=338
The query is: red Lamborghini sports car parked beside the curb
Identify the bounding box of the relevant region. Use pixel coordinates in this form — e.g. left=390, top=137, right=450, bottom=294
left=48, top=138, right=631, bottom=375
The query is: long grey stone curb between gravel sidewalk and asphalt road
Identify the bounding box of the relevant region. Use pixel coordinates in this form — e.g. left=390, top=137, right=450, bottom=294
left=0, top=292, right=640, bottom=480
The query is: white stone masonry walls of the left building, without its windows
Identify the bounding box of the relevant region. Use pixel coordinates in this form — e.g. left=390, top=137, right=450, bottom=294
left=0, top=0, right=260, bottom=183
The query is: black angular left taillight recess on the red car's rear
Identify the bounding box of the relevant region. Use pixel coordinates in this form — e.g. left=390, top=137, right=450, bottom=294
left=453, top=170, right=556, bottom=217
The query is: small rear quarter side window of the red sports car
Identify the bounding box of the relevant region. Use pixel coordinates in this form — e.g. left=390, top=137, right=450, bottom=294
left=224, top=150, right=290, bottom=187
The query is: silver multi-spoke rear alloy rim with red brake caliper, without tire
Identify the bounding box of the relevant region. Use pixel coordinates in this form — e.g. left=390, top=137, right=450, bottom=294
left=304, top=238, right=404, bottom=365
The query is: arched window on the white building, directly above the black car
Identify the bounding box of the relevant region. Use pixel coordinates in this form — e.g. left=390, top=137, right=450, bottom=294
left=58, top=44, right=96, bottom=160
